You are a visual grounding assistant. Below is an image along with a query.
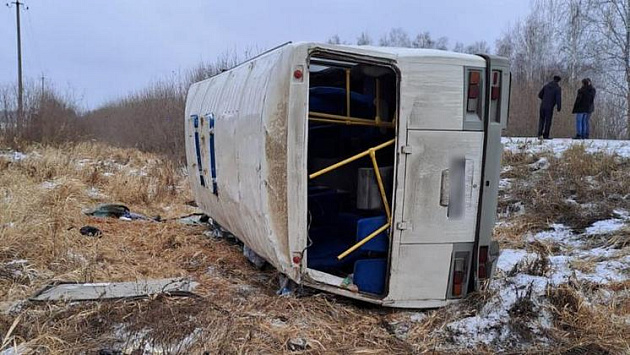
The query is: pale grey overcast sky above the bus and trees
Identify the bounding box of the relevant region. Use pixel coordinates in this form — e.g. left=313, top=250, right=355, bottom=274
left=0, top=0, right=529, bottom=108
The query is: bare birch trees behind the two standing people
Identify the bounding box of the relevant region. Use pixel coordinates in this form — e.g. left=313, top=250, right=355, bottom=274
left=502, top=0, right=630, bottom=139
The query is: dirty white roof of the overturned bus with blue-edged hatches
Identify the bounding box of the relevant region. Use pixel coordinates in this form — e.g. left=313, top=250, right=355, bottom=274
left=186, top=49, right=289, bottom=270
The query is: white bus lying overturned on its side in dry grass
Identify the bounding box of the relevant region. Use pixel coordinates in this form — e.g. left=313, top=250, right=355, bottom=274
left=185, top=43, right=510, bottom=308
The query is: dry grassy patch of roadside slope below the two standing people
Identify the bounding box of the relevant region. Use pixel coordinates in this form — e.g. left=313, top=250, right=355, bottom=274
left=497, top=144, right=630, bottom=243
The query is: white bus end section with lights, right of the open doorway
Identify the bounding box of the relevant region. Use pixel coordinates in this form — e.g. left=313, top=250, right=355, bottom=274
left=384, top=56, right=510, bottom=308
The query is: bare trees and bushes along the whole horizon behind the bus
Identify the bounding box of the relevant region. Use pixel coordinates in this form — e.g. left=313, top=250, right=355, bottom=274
left=0, top=0, right=630, bottom=162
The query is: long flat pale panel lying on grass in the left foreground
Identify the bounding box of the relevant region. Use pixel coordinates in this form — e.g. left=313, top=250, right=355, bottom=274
left=30, top=278, right=199, bottom=301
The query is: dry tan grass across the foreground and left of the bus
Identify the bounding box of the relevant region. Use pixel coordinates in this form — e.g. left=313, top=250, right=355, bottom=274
left=0, top=143, right=630, bottom=354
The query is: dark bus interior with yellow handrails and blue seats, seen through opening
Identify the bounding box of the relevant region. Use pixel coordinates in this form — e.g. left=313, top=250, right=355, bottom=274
left=306, top=54, right=398, bottom=297
